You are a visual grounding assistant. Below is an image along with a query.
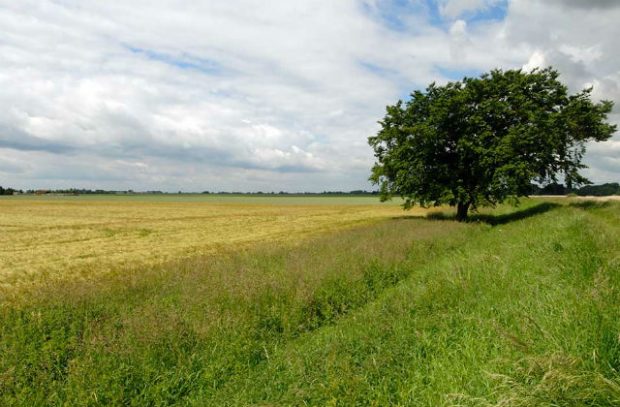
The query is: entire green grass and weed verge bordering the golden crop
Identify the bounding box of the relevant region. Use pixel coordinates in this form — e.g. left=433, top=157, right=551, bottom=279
left=0, top=203, right=620, bottom=406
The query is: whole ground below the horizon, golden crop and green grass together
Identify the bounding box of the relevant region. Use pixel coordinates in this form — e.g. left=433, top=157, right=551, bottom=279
left=0, top=196, right=620, bottom=406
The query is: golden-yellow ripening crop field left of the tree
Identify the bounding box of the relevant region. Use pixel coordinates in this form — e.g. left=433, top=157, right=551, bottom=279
left=0, top=197, right=420, bottom=290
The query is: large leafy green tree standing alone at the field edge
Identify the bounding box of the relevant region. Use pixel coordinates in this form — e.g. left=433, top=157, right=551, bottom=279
left=368, top=68, right=616, bottom=220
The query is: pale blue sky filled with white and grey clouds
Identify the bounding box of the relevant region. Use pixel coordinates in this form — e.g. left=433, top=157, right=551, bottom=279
left=0, top=0, right=620, bottom=192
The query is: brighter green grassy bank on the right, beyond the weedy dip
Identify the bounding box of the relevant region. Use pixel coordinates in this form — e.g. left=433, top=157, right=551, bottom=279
left=211, top=205, right=620, bottom=406
